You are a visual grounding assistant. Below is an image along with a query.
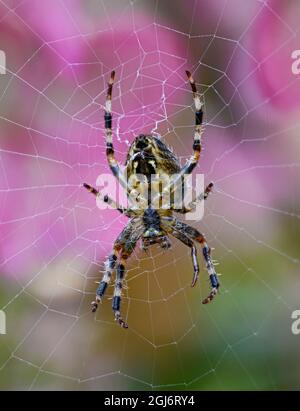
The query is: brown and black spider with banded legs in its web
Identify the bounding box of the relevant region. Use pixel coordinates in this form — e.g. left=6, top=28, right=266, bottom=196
left=83, top=71, right=219, bottom=328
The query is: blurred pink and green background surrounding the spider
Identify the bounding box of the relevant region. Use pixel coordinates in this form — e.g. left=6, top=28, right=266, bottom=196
left=0, top=0, right=300, bottom=390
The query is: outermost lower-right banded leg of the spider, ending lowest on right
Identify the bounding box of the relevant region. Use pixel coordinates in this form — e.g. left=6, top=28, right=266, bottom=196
left=161, top=217, right=220, bottom=304
